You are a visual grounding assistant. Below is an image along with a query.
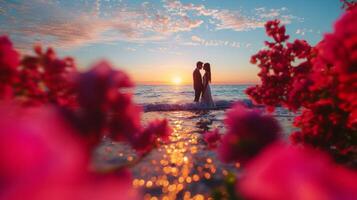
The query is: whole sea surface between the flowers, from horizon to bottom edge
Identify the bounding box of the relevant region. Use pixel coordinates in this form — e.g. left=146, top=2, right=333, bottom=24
left=93, top=85, right=294, bottom=199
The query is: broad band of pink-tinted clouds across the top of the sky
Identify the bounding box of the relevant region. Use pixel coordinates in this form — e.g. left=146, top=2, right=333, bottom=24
left=0, top=0, right=299, bottom=50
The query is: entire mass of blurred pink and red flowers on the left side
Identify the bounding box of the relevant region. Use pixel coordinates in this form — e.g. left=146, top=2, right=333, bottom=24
left=0, top=36, right=171, bottom=200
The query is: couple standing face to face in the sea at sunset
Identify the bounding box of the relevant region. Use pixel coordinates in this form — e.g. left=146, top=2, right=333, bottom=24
left=193, top=61, right=215, bottom=108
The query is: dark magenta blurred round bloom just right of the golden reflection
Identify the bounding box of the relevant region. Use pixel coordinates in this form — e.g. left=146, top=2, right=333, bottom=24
left=218, top=104, right=281, bottom=162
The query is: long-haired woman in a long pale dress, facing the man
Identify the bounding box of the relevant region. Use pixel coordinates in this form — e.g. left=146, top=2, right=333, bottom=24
left=201, top=63, right=215, bottom=108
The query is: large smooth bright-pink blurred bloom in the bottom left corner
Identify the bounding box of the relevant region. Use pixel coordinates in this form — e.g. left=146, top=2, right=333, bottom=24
left=0, top=105, right=85, bottom=199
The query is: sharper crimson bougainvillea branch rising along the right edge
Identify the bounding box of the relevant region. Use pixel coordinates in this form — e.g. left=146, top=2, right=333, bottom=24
left=246, top=7, right=357, bottom=162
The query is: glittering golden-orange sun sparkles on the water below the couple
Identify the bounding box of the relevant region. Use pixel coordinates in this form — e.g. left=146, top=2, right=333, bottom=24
left=129, top=111, right=229, bottom=200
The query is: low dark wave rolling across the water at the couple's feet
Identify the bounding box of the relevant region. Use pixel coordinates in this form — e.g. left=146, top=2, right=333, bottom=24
left=142, top=99, right=253, bottom=112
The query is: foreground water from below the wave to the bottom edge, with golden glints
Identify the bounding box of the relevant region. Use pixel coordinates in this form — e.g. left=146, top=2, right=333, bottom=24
left=93, top=111, right=291, bottom=200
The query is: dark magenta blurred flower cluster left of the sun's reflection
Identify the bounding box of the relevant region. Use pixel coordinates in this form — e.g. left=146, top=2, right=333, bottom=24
left=66, top=61, right=171, bottom=153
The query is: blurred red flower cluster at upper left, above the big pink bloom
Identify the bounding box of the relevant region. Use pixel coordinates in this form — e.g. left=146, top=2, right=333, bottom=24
left=14, top=46, right=77, bottom=107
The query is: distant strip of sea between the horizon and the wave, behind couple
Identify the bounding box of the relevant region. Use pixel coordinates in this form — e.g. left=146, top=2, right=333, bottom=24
left=134, top=85, right=249, bottom=111
